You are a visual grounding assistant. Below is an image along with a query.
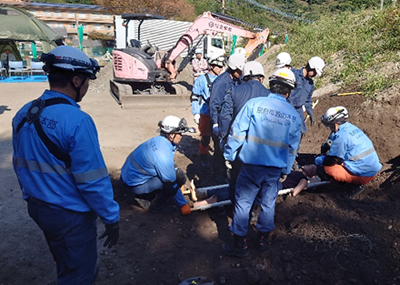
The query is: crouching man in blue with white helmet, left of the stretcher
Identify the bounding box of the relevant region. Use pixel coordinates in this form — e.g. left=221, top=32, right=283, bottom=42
left=121, top=116, right=191, bottom=215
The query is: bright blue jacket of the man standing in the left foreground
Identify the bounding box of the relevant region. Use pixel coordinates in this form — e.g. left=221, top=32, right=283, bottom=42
left=12, top=90, right=119, bottom=224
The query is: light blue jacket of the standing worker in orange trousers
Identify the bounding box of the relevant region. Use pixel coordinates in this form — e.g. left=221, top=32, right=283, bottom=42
left=192, top=73, right=217, bottom=116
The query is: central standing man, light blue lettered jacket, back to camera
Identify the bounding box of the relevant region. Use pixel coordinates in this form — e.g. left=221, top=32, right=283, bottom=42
left=222, top=68, right=301, bottom=257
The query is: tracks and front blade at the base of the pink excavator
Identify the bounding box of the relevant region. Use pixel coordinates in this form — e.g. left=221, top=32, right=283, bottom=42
left=110, top=80, right=191, bottom=109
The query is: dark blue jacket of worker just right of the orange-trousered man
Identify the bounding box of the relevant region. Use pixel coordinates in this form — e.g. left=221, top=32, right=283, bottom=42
left=209, top=71, right=240, bottom=124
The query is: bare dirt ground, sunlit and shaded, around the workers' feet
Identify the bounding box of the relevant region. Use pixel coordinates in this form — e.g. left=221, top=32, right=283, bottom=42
left=0, top=66, right=400, bottom=285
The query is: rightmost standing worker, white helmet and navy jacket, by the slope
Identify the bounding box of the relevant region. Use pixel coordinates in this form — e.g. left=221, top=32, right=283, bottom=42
left=288, top=56, right=325, bottom=166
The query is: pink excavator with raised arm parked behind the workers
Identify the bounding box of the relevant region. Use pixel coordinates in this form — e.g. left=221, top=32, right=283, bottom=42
left=110, top=12, right=269, bottom=106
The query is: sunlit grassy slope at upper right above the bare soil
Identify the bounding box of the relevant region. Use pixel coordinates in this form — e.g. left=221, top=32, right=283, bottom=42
left=287, top=8, right=400, bottom=95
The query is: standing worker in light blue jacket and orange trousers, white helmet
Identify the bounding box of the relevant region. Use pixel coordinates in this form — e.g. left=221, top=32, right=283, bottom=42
left=190, top=55, right=225, bottom=167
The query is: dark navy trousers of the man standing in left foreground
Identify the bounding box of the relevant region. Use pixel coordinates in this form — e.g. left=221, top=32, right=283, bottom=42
left=28, top=198, right=97, bottom=285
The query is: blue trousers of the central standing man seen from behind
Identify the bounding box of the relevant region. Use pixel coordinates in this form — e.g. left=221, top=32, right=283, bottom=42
left=231, top=164, right=282, bottom=236
